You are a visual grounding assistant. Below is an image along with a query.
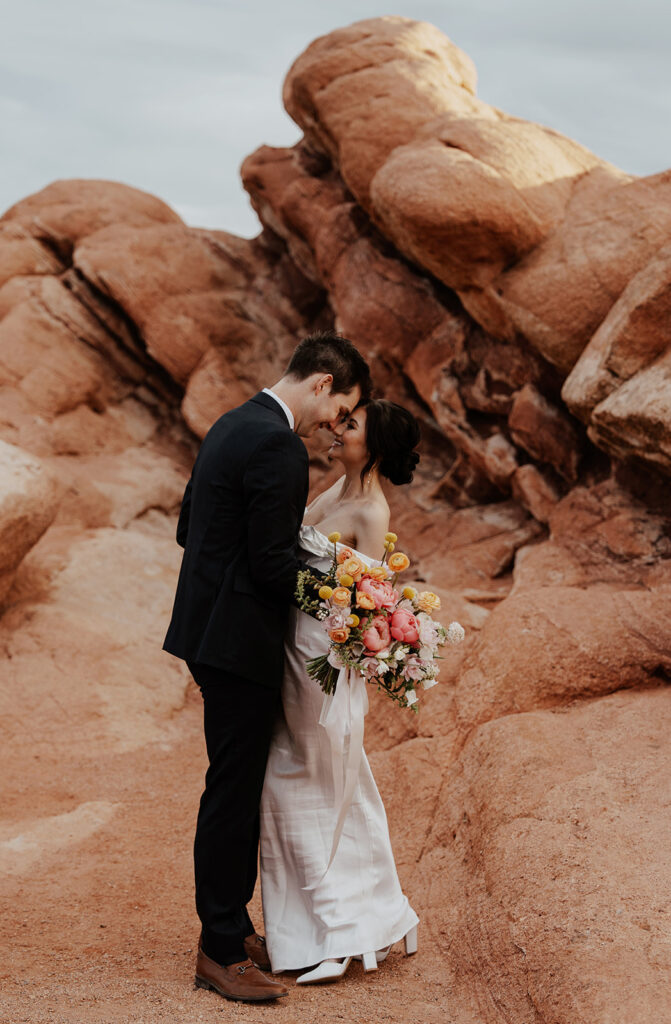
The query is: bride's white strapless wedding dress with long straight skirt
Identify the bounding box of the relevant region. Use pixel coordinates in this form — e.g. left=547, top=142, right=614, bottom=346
left=260, top=526, right=418, bottom=971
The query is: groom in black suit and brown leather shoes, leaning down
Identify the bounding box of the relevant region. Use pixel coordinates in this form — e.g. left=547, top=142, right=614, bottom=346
left=164, top=332, right=370, bottom=1001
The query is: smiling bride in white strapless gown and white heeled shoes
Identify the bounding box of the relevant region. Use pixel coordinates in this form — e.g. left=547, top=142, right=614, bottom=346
left=260, top=399, right=419, bottom=984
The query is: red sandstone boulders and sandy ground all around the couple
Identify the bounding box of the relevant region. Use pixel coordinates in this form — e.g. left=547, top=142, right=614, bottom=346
left=0, top=18, right=671, bottom=1024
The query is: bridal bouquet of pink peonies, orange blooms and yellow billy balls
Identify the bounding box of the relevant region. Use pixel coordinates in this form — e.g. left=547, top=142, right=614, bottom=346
left=296, top=532, right=464, bottom=711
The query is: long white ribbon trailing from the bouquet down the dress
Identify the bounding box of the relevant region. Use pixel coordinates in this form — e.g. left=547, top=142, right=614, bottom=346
left=303, top=668, right=368, bottom=892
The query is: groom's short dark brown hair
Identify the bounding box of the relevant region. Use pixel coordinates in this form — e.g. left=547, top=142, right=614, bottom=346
left=285, top=331, right=371, bottom=401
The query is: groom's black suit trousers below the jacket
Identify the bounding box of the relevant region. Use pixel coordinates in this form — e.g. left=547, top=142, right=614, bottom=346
left=188, top=663, right=280, bottom=965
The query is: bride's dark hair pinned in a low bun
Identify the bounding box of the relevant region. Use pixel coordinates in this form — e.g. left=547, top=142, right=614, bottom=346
left=361, top=398, right=421, bottom=484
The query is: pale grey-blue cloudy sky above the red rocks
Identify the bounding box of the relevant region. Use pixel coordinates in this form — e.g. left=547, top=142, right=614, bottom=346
left=0, top=0, right=671, bottom=238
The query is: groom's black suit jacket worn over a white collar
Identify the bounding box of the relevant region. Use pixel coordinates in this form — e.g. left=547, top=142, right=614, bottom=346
left=163, top=391, right=308, bottom=687
